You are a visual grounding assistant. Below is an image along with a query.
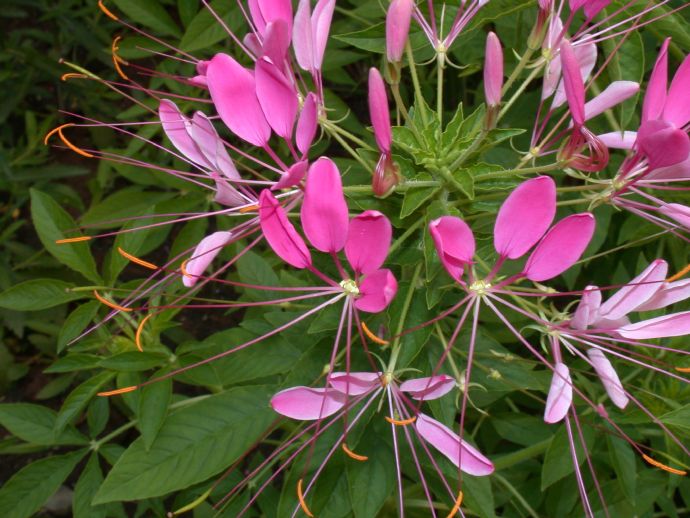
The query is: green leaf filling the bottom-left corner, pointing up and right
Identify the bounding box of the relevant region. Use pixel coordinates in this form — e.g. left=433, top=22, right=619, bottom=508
left=0, top=450, right=87, bottom=518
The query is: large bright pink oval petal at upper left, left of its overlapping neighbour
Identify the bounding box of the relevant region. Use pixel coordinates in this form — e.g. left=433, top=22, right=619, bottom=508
left=207, top=54, right=271, bottom=147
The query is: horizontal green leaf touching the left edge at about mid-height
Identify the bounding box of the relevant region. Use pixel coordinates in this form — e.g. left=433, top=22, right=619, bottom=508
left=0, top=279, right=84, bottom=311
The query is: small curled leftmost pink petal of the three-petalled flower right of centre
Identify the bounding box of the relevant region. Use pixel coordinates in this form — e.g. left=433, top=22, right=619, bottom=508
left=429, top=216, right=475, bottom=280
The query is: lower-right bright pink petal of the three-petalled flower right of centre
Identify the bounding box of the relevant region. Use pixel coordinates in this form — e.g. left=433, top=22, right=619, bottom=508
left=523, top=212, right=596, bottom=282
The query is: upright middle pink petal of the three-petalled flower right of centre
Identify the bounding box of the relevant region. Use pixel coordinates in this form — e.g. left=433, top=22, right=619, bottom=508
left=494, top=176, right=556, bottom=259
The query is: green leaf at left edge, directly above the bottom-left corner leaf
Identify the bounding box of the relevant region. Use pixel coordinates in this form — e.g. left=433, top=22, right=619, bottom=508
left=0, top=403, right=88, bottom=446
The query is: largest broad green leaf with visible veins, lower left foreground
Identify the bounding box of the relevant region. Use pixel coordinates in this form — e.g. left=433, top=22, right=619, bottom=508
left=94, top=387, right=275, bottom=503
